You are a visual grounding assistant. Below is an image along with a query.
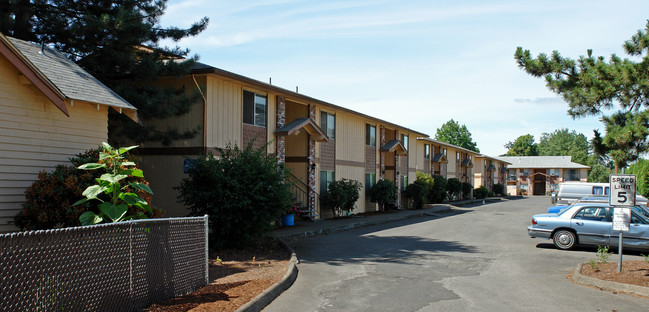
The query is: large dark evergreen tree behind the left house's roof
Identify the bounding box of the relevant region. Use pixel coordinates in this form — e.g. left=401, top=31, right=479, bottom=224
left=0, top=0, right=208, bottom=145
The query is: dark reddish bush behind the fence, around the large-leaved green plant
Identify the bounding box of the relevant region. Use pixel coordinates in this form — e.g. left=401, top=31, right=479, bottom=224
left=13, top=148, right=158, bottom=230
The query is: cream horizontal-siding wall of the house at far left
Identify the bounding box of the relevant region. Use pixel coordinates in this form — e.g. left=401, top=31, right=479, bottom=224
left=0, top=57, right=108, bottom=232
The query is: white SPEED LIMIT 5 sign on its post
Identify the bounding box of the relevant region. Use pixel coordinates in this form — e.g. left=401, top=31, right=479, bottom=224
left=609, top=174, right=636, bottom=272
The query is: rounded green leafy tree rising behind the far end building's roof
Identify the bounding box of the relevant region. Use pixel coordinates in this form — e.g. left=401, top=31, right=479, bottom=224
left=538, top=128, right=589, bottom=165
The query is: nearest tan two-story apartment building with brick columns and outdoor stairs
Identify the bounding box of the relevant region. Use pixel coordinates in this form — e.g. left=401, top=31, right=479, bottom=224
left=134, top=63, right=426, bottom=218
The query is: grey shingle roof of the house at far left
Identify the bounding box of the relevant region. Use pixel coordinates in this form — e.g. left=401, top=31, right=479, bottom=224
left=7, top=37, right=137, bottom=119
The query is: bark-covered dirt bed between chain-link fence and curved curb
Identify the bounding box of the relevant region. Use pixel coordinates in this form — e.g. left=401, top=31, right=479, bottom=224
left=142, top=239, right=291, bottom=312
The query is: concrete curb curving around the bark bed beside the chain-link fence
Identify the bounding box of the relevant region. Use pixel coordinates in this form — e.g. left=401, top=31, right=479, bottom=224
left=237, top=239, right=299, bottom=312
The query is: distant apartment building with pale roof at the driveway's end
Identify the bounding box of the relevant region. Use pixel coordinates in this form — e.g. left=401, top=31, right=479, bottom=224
left=498, top=156, right=590, bottom=195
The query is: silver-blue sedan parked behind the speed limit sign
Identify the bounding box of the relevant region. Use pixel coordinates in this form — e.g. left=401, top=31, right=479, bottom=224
left=527, top=203, right=649, bottom=249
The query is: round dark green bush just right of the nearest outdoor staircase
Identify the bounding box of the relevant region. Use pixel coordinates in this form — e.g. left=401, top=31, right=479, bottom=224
left=320, top=179, right=361, bottom=218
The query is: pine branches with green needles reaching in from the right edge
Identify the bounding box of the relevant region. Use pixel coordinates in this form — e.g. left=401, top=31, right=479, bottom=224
left=515, top=22, right=649, bottom=171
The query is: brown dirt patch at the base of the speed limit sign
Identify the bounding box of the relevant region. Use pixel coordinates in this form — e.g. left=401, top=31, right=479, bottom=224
left=581, top=261, right=649, bottom=287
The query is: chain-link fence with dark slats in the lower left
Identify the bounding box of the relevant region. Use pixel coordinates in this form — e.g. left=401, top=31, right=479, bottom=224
left=0, top=215, right=208, bottom=311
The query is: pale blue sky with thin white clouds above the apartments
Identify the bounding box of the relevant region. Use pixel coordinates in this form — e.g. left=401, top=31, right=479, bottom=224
left=161, top=0, right=649, bottom=156
